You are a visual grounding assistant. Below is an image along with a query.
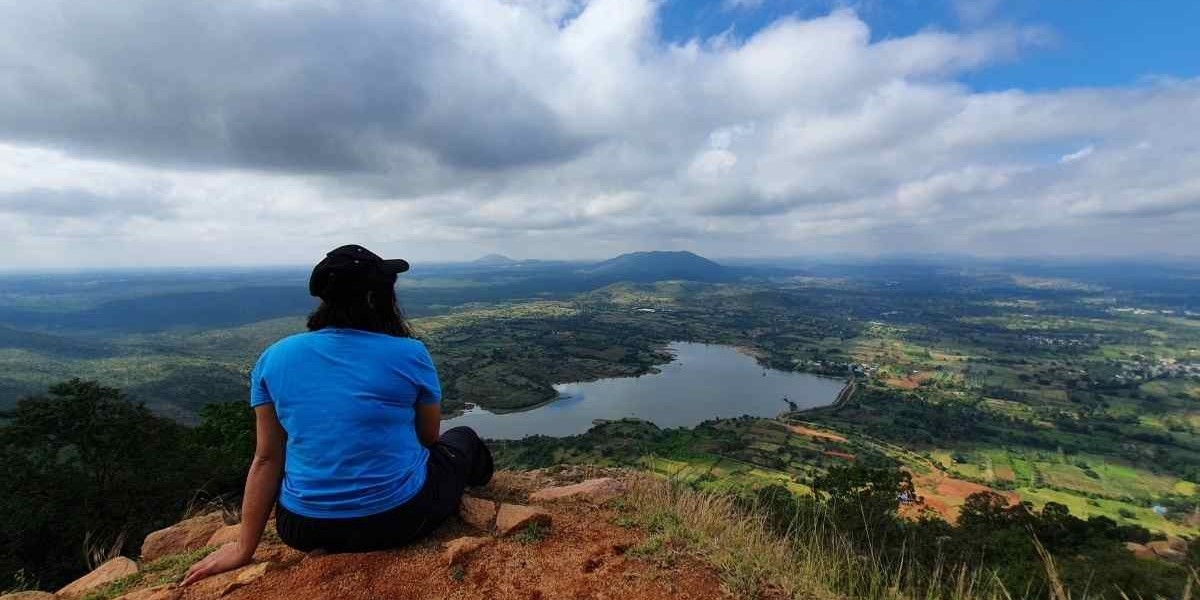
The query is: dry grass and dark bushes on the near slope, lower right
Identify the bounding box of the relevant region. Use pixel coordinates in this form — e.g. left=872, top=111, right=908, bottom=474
left=618, top=467, right=1200, bottom=600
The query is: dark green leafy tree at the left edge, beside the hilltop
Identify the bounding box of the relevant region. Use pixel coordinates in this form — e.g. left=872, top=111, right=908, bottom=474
left=0, top=379, right=205, bottom=589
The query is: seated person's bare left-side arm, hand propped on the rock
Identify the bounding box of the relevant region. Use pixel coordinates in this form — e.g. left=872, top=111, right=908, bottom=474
left=181, top=404, right=286, bottom=586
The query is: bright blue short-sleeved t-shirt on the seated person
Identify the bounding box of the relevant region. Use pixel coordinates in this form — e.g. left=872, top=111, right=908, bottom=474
left=250, top=328, right=442, bottom=518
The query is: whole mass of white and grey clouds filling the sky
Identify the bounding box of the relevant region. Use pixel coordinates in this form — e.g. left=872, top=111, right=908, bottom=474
left=0, top=0, right=1200, bottom=266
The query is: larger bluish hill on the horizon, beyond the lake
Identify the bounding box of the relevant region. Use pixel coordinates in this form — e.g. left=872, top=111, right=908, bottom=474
left=580, top=251, right=736, bottom=283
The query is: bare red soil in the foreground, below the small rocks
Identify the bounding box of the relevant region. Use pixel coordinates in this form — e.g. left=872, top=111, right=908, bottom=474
left=196, top=473, right=725, bottom=600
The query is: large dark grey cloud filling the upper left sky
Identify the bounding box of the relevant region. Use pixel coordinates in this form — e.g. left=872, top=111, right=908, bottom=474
left=0, top=0, right=587, bottom=172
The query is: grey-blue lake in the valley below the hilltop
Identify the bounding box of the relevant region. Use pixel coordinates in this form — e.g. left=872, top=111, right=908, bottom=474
left=442, top=342, right=844, bottom=439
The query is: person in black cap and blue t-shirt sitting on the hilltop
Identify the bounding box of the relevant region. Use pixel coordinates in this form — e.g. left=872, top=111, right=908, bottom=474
left=182, top=245, right=492, bottom=586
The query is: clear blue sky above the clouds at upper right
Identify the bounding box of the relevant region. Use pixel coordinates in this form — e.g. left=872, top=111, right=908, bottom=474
left=659, top=0, right=1200, bottom=91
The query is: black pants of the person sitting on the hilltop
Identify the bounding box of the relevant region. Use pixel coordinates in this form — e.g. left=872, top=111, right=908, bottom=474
left=275, top=427, right=492, bottom=552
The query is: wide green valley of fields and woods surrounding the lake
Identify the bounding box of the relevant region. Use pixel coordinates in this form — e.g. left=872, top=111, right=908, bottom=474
left=0, top=252, right=1200, bottom=552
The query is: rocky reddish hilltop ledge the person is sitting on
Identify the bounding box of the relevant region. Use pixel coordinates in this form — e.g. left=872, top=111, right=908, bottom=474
left=32, top=469, right=727, bottom=600
